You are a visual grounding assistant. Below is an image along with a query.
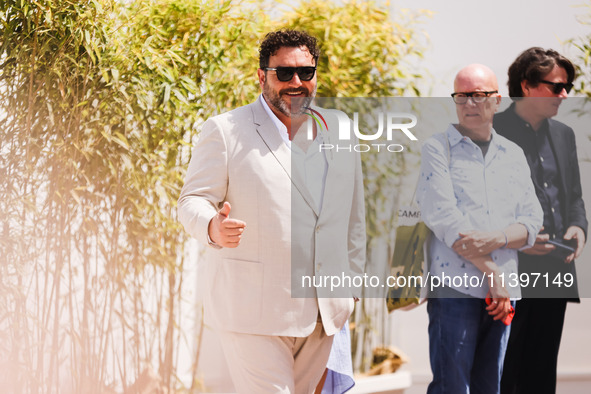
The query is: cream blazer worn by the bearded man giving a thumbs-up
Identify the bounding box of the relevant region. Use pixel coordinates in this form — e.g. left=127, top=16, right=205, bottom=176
left=178, top=97, right=365, bottom=337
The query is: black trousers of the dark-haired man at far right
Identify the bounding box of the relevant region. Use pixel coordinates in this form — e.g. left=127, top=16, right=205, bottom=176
left=501, top=298, right=567, bottom=394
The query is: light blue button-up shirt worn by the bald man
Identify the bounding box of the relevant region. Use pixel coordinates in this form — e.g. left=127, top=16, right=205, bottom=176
left=417, top=125, right=543, bottom=299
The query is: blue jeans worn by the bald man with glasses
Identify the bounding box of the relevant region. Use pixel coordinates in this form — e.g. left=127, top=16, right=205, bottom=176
left=427, top=296, right=515, bottom=394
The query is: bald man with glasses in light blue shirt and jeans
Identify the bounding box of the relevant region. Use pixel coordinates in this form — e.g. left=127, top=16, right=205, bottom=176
left=418, top=64, right=543, bottom=394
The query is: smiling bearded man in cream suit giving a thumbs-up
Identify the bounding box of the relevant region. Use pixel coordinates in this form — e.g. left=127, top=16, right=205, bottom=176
left=179, top=30, right=365, bottom=393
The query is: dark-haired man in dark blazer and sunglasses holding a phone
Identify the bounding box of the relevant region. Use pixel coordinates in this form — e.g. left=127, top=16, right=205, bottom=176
left=494, top=47, right=587, bottom=394
